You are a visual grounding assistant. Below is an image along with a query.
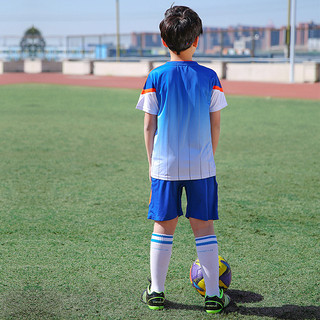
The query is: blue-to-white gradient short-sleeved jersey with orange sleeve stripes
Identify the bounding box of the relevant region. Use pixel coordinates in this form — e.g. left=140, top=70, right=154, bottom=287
left=136, top=61, right=227, bottom=181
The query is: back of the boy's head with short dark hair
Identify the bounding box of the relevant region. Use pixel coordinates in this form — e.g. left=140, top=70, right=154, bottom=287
left=159, top=6, right=202, bottom=55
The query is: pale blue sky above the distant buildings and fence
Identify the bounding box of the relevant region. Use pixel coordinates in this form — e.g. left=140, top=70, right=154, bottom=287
left=0, top=0, right=320, bottom=36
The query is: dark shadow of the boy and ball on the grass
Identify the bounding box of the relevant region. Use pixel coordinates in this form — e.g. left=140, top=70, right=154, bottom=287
left=166, top=290, right=320, bottom=320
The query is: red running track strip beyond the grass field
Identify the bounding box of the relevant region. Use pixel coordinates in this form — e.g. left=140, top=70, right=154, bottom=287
left=0, top=73, right=320, bottom=100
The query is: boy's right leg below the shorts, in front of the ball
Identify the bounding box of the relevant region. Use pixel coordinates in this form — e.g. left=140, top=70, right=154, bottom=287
left=189, top=218, right=220, bottom=297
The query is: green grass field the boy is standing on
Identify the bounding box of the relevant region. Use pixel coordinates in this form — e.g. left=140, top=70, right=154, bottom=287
left=0, top=84, right=320, bottom=320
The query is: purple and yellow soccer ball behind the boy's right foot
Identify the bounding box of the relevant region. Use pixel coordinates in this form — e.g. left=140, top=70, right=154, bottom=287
left=190, top=256, right=232, bottom=296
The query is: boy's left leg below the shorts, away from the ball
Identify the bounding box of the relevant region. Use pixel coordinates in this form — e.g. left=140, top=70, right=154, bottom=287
left=150, top=217, right=178, bottom=292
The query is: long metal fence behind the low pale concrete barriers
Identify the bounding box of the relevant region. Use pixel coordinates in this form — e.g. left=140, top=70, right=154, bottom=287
left=0, top=24, right=320, bottom=60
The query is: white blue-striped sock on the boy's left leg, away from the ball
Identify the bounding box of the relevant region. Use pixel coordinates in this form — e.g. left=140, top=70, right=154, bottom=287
left=150, top=233, right=173, bottom=292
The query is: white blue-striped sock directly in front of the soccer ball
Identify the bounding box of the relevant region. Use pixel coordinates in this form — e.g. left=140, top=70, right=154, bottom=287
left=196, top=235, right=220, bottom=297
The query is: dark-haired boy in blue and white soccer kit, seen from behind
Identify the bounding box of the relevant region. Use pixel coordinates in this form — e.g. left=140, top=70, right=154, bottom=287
left=136, top=6, right=230, bottom=313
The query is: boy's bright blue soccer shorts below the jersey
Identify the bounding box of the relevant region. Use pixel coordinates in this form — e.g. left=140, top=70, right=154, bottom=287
left=148, top=177, right=219, bottom=221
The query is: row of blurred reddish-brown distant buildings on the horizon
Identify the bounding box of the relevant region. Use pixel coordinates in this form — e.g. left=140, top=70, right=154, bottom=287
left=131, top=22, right=320, bottom=55
